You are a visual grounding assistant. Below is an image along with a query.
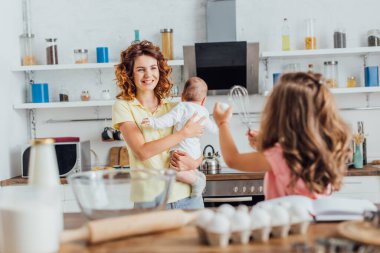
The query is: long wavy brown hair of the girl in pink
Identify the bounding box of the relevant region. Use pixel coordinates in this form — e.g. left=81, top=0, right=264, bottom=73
left=258, top=72, right=352, bottom=193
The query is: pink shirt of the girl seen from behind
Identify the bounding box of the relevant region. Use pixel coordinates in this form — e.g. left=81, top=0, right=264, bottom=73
left=264, top=143, right=331, bottom=199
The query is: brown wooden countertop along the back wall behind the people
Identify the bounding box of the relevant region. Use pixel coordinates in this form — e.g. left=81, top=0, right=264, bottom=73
left=0, top=164, right=380, bottom=186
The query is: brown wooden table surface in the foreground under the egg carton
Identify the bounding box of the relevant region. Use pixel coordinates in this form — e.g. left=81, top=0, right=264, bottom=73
left=59, top=214, right=337, bottom=253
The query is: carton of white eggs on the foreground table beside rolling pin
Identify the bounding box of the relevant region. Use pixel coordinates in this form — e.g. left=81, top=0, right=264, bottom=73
left=196, top=204, right=310, bottom=247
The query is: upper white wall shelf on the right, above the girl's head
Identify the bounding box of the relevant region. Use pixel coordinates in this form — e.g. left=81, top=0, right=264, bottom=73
left=260, top=47, right=380, bottom=59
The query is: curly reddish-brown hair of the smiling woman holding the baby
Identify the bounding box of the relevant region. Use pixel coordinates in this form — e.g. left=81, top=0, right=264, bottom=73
left=115, top=40, right=173, bottom=101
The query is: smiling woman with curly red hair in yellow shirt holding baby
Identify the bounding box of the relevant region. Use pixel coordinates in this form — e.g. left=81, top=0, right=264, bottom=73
left=112, top=41, right=204, bottom=209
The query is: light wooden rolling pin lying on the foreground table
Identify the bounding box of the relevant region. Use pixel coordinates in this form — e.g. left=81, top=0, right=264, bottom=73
left=60, top=210, right=198, bottom=243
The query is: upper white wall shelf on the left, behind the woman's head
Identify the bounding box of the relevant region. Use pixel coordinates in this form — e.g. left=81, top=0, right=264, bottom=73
left=12, top=60, right=183, bottom=71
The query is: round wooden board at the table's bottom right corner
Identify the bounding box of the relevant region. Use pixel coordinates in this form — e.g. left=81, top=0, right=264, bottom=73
left=338, top=221, right=380, bottom=246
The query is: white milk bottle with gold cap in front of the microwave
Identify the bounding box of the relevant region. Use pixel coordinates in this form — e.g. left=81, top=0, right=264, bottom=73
left=28, top=138, right=60, bottom=186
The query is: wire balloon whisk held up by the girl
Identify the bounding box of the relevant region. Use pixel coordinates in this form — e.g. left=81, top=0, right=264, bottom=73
left=229, top=85, right=253, bottom=130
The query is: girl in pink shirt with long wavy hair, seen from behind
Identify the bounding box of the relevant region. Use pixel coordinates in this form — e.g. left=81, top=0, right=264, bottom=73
left=214, top=72, right=351, bottom=199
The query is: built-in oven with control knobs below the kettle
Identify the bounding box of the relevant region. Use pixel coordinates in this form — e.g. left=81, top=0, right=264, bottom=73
left=203, top=168, right=264, bottom=207
